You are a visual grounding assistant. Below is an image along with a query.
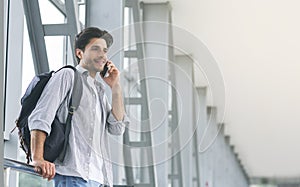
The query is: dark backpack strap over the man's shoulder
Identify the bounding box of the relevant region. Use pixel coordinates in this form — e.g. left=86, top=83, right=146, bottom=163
left=57, top=65, right=82, bottom=162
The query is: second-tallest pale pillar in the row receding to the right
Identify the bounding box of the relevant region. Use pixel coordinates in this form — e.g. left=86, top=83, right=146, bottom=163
left=175, top=55, right=199, bottom=187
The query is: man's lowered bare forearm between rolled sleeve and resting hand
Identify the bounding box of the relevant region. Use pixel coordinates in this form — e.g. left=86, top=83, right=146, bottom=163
left=30, top=130, right=47, bottom=160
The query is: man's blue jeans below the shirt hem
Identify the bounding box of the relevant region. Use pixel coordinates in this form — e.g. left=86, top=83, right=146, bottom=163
left=54, top=174, right=106, bottom=187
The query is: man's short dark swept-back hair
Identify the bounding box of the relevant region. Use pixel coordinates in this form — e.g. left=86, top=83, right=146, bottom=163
left=74, top=27, right=113, bottom=63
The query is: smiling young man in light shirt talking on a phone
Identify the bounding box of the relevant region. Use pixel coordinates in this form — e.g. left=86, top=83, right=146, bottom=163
left=29, top=27, right=129, bottom=187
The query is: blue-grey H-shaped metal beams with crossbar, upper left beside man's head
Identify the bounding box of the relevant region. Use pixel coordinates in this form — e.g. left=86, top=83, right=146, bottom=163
left=23, top=0, right=80, bottom=74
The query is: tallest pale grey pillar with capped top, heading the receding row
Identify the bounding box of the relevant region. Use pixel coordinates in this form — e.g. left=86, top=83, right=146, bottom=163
left=142, top=3, right=170, bottom=186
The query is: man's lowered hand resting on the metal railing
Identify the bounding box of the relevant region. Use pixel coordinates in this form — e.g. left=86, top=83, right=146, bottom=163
left=32, top=159, right=55, bottom=180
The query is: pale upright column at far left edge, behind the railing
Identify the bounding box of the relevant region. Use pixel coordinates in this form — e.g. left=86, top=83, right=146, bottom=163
left=4, top=0, right=24, bottom=187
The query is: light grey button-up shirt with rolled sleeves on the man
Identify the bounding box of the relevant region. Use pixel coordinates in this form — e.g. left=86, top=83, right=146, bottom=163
left=29, top=66, right=129, bottom=186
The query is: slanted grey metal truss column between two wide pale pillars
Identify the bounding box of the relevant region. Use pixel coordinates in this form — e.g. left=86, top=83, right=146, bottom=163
left=124, top=0, right=156, bottom=187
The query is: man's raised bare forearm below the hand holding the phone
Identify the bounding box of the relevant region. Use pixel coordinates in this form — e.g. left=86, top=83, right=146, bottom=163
left=112, top=84, right=125, bottom=121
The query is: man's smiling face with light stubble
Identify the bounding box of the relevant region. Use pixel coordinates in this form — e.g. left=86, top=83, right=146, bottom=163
left=80, top=38, right=108, bottom=76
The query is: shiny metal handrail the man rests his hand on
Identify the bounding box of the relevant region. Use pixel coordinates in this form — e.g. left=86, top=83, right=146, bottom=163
left=4, top=158, right=134, bottom=187
